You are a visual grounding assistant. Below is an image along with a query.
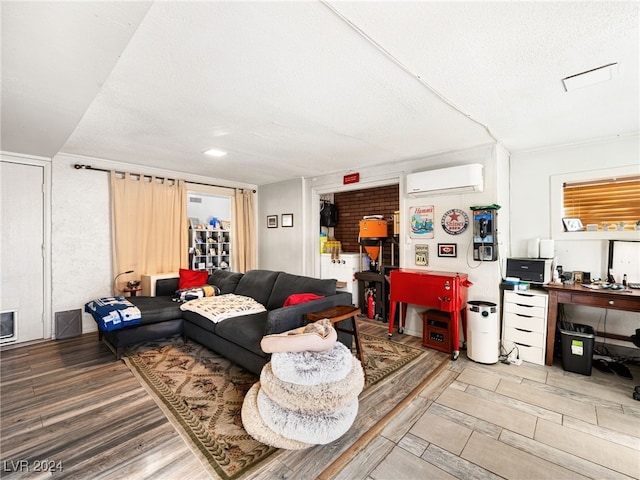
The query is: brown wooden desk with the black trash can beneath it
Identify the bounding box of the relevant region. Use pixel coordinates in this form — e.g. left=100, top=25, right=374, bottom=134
left=545, top=284, right=640, bottom=365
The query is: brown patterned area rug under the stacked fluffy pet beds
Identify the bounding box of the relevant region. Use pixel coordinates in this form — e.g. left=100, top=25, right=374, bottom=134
left=124, top=334, right=425, bottom=480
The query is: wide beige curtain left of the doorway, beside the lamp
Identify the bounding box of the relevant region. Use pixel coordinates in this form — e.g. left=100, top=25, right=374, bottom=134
left=111, top=171, right=189, bottom=294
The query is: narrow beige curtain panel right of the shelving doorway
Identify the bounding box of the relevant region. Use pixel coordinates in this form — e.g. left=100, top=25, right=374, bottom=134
left=231, top=189, right=256, bottom=273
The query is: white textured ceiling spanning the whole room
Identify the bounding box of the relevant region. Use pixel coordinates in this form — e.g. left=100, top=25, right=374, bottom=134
left=1, top=1, right=640, bottom=185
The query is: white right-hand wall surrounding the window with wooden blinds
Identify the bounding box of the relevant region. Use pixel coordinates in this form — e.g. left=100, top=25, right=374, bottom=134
left=510, top=135, right=640, bottom=345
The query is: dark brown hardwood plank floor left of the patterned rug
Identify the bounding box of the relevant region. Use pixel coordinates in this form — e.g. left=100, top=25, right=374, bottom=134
left=0, top=334, right=207, bottom=479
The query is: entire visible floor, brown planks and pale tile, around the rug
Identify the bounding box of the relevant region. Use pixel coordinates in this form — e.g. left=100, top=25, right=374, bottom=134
left=0, top=320, right=640, bottom=480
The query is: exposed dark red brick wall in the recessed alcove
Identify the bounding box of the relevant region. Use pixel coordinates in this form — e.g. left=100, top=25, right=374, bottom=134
left=334, top=185, right=400, bottom=265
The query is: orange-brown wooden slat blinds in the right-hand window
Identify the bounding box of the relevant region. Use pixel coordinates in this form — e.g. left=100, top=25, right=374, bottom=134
left=562, top=175, right=640, bottom=231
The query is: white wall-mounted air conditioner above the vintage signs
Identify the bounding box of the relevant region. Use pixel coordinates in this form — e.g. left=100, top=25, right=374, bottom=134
left=407, top=163, right=484, bottom=197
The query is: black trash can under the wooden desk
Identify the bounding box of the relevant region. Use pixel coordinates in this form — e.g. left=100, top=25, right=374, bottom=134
left=559, top=322, right=596, bottom=375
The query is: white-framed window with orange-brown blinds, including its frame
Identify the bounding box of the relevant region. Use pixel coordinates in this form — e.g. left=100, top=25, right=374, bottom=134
left=549, top=164, right=640, bottom=240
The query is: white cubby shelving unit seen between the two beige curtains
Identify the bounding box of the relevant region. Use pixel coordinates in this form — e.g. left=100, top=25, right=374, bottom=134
left=189, top=228, right=231, bottom=273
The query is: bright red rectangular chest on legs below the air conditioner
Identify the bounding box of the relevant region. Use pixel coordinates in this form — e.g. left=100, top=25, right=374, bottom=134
left=389, top=268, right=473, bottom=360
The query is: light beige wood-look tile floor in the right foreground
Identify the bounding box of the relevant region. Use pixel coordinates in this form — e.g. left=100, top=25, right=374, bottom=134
left=348, top=318, right=640, bottom=480
